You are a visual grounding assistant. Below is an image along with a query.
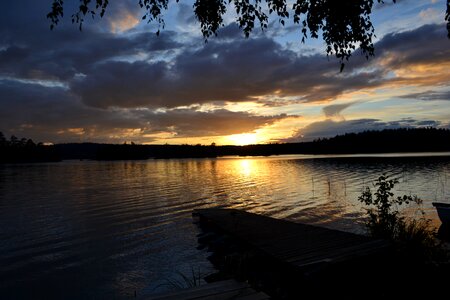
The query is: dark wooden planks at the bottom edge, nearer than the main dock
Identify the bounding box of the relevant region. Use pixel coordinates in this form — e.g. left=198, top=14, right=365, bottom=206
left=150, top=279, right=270, bottom=300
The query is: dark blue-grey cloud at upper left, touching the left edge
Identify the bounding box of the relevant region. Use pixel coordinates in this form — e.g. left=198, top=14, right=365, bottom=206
left=0, top=29, right=180, bottom=82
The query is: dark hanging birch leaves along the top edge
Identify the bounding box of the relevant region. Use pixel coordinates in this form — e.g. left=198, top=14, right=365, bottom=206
left=47, top=0, right=450, bottom=70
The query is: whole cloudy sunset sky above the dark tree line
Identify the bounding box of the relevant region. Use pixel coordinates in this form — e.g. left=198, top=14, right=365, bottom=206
left=0, top=0, right=450, bottom=145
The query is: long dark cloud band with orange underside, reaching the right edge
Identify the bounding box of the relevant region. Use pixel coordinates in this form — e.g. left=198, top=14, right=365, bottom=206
left=74, top=25, right=450, bottom=107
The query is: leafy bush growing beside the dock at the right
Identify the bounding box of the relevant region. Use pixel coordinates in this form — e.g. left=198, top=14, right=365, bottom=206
left=358, top=175, right=444, bottom=262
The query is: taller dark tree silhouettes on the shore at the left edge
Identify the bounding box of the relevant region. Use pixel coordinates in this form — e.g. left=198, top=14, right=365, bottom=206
left=0, top=132, right=61, bottom=163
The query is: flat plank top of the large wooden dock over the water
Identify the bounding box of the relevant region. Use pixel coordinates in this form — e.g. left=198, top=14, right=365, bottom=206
left=194, top=209, right=389, bottom=267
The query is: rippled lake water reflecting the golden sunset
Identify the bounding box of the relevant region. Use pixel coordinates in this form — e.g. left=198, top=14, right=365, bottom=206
left=0, top=153, right=450, bottom=299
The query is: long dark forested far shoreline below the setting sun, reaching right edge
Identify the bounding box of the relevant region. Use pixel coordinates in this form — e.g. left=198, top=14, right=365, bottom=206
left=55, top=128, right=450, bottom=160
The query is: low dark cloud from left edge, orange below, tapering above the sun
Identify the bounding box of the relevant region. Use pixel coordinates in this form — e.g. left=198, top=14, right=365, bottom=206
left=0, top=80, right=295, bottom=142
